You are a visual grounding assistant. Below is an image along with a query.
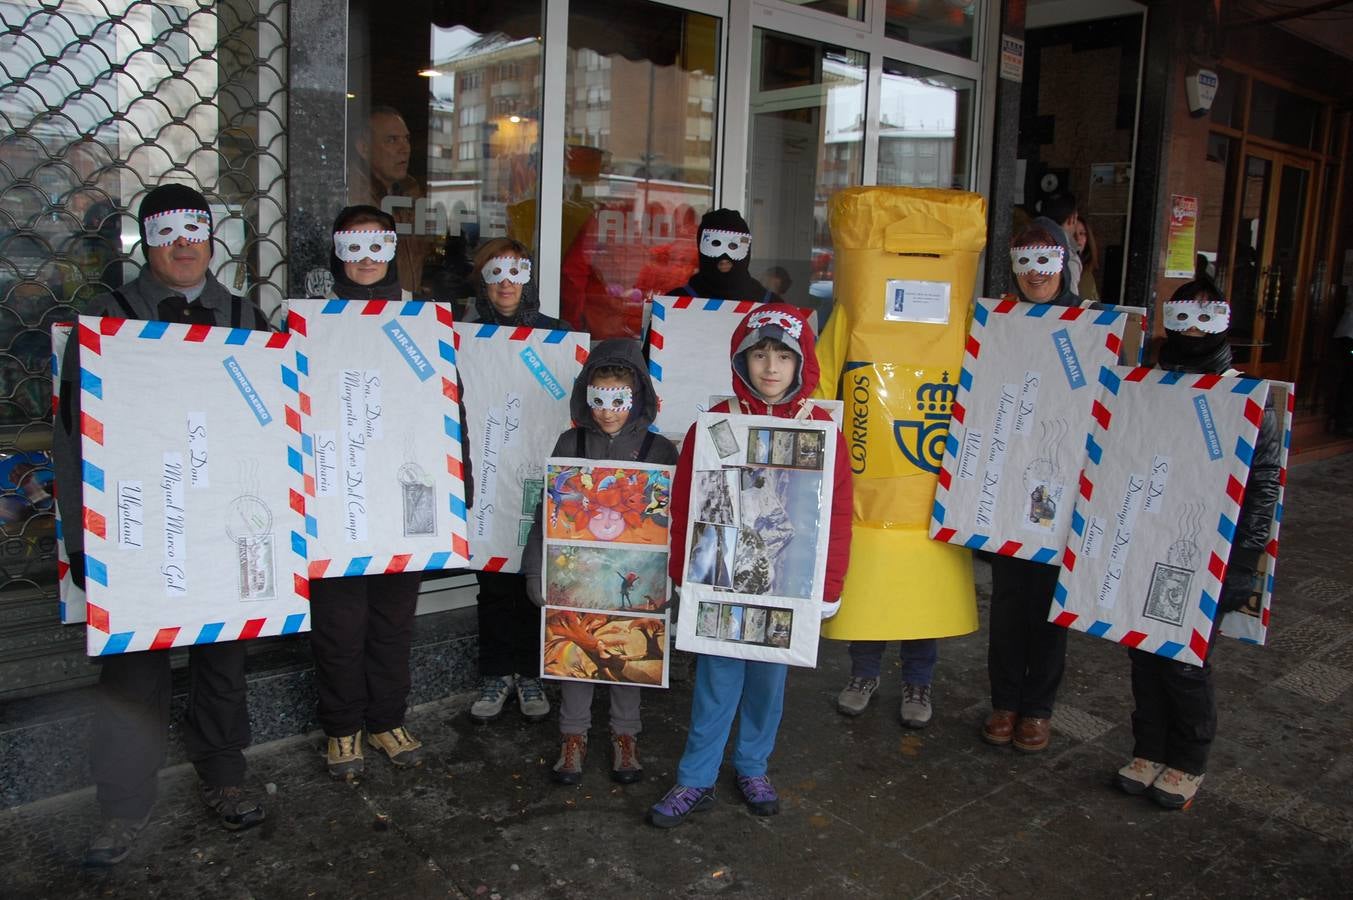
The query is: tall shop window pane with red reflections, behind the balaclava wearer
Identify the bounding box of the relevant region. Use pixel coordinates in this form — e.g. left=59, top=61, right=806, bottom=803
left=560, top=0, right=720, bottom=340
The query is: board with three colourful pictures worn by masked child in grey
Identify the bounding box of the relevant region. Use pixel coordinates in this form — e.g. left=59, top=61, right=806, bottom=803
left=540, top=457, right=672, bottom=688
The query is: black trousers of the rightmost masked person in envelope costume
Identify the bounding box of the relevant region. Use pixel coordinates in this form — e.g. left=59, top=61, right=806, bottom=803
left=1127, top=628, right=1216, bottom=775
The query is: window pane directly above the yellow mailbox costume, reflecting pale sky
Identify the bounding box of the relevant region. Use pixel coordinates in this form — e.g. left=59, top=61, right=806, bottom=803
left=878, top=60, right=974, bottom=191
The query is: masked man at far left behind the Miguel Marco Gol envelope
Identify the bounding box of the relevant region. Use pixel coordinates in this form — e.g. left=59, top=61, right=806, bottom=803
left=53, top=184, right=269, bottom=866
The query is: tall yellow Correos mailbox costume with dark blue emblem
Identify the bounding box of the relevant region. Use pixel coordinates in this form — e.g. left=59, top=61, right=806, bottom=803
left=817, top=187, right=986, bottom=640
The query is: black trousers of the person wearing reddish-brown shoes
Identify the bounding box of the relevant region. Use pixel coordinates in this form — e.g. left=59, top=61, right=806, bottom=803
left=986, top=556, right=1066, bottom=719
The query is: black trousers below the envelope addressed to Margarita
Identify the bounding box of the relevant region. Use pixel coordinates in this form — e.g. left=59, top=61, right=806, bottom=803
left=310, top=572, right=422, bottom=738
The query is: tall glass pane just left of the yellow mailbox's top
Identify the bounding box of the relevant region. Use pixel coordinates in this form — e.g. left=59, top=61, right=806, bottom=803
left=744, top=28, right=869, bottom=323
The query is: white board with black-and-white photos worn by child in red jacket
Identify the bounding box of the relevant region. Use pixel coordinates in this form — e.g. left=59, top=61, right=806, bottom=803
left=677, top=413, right=836, bottom=666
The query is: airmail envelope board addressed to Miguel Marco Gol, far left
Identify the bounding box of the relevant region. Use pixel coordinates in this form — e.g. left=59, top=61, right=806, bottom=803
left=77, top=315, right=310, bottom=655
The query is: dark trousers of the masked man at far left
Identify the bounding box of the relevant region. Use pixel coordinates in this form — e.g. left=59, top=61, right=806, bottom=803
left=91, top=640, right=249, bottom=819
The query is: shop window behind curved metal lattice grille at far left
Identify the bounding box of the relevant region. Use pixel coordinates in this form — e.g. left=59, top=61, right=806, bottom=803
left=0, top=0, right=288, bottom=690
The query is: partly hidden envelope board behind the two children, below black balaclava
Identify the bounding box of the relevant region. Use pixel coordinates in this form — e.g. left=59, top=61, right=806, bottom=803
left=648, top=296, right=763, bottom=440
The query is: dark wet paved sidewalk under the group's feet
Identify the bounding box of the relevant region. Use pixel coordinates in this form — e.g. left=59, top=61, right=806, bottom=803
left=0, top=456, right=1353, bottom=900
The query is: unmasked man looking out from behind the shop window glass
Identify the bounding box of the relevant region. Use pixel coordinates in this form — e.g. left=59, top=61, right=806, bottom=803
left=348, top=106, right=432, bottom=299
